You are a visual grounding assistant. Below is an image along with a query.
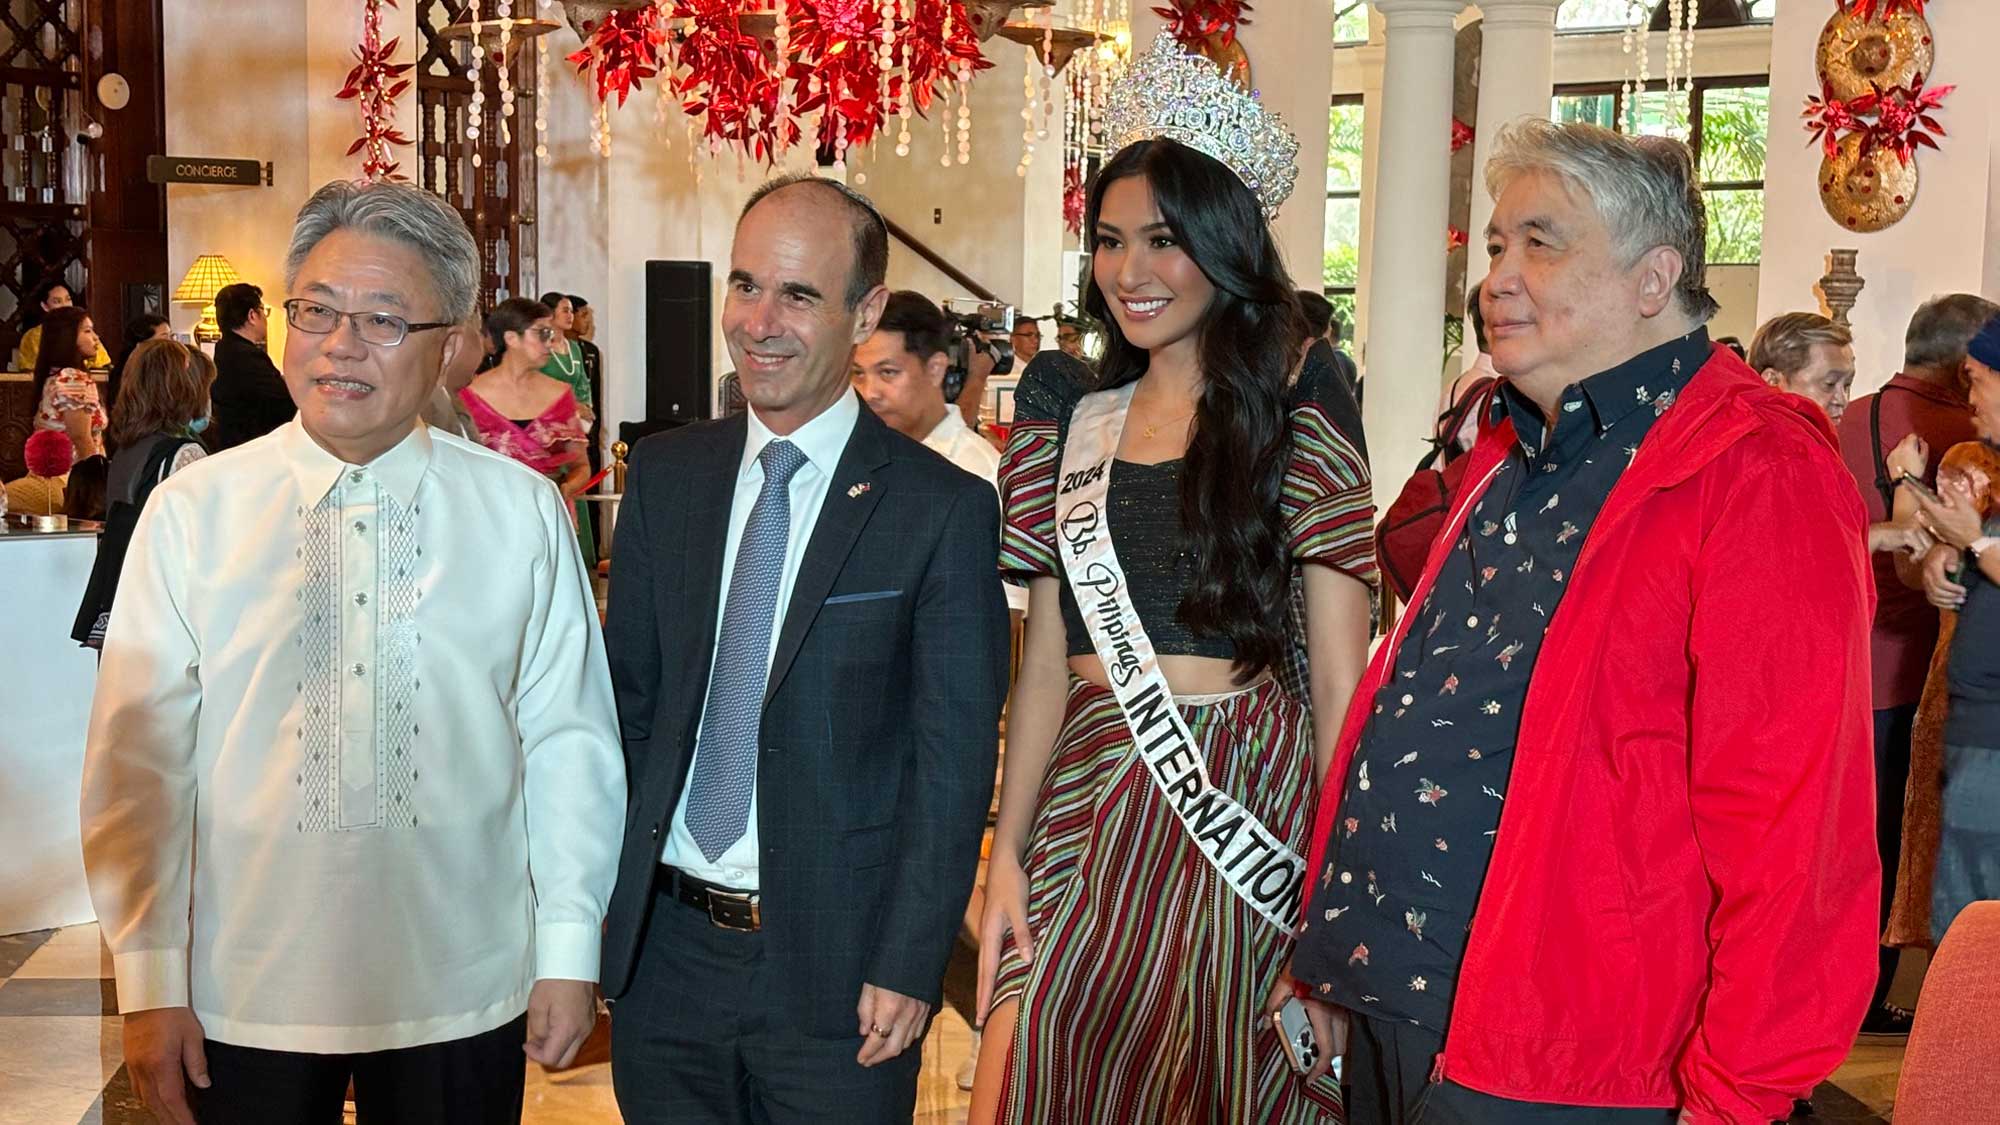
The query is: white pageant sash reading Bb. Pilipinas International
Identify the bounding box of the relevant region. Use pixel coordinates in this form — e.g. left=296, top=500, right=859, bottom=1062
left=1056, top=382, right=1306, bottom=935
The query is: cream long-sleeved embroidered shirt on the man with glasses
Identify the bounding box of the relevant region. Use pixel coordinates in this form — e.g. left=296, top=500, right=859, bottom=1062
left=82, top=418, right=626, bottom=1053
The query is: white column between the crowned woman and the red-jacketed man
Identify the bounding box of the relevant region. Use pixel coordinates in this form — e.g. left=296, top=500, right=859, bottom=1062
left=1364, top=0, right=1464, bottom=506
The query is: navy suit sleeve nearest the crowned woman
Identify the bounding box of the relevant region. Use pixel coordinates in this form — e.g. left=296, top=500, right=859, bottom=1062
left=864, top=486, right=1008, bottom=1007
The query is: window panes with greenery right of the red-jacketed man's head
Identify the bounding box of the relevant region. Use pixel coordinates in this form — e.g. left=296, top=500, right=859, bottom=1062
left=1544, top=76, right=1770, bottom=264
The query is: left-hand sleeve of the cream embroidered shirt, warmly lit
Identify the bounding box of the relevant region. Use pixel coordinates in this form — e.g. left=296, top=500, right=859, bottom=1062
left=82, top=490, right=202, bottom=1013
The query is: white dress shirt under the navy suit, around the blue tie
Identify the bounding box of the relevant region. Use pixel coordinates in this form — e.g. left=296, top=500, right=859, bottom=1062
left=660, top=384, right=862, bottom=891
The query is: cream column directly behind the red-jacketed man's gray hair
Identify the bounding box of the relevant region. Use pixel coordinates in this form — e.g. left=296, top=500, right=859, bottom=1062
left=1466, top=0, right=1562, bottom=282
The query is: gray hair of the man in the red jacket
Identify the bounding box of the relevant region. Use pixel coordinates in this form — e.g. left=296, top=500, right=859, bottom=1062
left=1486, top=118, right=1718, bottom=324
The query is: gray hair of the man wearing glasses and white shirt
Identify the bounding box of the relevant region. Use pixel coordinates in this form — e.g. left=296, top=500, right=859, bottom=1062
left=284, top=180, right=480, bottom=322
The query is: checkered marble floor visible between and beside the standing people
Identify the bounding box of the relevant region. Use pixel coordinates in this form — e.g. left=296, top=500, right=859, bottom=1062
left=0, top=925, right=1902, bottom=1125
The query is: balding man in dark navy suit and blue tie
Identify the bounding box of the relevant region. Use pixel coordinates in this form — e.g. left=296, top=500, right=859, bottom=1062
left=604, top=178, right=1008, bottom=1125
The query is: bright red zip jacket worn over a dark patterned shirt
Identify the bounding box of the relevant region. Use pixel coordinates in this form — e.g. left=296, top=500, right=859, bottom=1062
left=1308, top=344, right=1882, bottom=1123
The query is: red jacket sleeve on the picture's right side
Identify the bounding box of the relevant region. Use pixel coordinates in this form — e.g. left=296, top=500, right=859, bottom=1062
left=1676, top=450, right=1880, bottom=1125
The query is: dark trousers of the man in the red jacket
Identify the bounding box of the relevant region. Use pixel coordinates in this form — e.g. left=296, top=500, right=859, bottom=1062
left=1342, top=1013, right=1678, bottom=1125
